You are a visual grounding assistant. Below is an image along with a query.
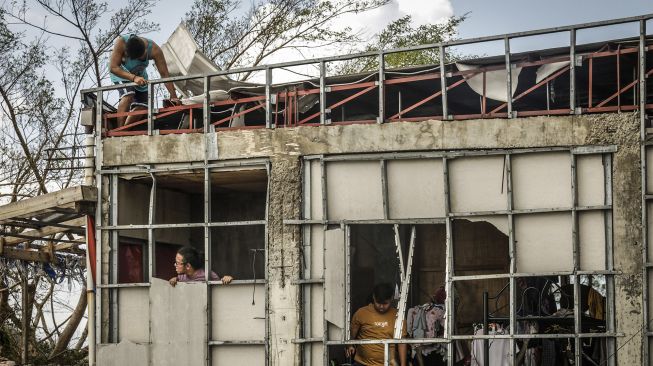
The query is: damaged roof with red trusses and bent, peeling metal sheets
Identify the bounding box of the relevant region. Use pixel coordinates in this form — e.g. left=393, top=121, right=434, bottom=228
left=85, top=20, right=653, bottom=137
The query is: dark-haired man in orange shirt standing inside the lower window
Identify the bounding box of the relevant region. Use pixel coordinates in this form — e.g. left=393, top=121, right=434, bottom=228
left=345, top=283, right=408, bottom=366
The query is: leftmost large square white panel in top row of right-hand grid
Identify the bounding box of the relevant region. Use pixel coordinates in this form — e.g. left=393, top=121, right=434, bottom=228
left=326, top=161, right=383, bottom=220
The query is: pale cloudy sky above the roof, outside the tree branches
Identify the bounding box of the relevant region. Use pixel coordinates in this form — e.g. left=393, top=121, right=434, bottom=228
left=139, top=0, right=653, bottom=69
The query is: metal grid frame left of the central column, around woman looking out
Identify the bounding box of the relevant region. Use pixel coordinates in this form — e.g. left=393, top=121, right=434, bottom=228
left=96, top=159, right=270, bottom=364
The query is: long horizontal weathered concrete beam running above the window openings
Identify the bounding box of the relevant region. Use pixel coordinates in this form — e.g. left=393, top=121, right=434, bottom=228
left=103, top=116, right=592, bottom=166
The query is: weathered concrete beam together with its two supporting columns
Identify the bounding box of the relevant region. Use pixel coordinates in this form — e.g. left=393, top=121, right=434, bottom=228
left=103, top=114, right=642, bottom=366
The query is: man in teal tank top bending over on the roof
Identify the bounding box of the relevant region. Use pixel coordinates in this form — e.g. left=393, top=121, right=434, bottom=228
left=109, top=34, right=180, bottom=126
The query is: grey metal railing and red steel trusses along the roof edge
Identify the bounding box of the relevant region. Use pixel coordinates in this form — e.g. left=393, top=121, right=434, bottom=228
left=82, top=14, right=653, bottom=137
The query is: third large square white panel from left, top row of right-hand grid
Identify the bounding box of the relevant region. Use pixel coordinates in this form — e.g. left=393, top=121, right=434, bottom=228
left=447, top=156, right=508, bottom=212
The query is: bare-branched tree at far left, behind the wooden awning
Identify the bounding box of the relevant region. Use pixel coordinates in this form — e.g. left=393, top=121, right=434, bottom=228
left=0, top=0, right=157, bottom=364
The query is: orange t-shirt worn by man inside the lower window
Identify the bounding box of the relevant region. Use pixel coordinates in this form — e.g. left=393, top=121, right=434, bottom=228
left=351, top=304, right=407, bottom=366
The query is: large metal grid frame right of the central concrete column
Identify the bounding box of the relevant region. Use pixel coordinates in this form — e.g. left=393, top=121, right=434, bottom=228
left=294, top=146, right=620, bottom=365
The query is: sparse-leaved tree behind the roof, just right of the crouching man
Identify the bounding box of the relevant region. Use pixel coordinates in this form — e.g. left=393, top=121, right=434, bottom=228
left=185, top=0, right=388, bottom=80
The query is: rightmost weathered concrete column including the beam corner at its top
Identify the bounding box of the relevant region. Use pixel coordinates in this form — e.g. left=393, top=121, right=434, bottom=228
left=584, top=113, right=643, bottom=365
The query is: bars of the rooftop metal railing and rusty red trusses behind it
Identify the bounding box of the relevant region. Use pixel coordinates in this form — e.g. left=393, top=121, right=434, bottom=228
left=82, top=14, right=653, bottom=136
